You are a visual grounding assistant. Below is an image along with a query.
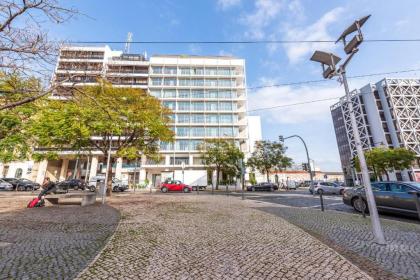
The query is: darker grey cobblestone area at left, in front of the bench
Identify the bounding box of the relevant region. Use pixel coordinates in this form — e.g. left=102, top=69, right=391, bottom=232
left=0, top=193, right=119, bottom=279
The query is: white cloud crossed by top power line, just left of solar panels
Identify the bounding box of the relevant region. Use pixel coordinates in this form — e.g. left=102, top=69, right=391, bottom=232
left=284, top=7, right=344, bottom=63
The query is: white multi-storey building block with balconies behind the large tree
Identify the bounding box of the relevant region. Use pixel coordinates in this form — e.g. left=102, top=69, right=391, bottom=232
left=0, top=46, right=261, bottom=185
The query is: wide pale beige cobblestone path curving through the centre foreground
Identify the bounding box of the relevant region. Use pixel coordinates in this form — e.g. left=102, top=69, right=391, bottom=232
left=80, top=193, right=372, bottom=279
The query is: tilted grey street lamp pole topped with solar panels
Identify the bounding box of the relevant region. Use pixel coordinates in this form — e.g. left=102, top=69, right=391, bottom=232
left=311, top=15, right=385, bottom=244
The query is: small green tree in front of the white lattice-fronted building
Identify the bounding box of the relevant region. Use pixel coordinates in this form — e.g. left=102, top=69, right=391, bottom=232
left=355, top=147, right=416, bottom=181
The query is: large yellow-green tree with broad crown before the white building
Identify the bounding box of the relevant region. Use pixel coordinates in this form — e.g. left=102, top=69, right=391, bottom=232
left=30, top=81, right=173, bottom=196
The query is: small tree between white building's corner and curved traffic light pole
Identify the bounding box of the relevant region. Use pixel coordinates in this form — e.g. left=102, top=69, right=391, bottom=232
left=247, top=141, right=292, bottom=182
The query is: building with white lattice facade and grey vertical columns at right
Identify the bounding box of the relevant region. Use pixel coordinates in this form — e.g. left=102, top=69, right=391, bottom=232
left=331, top=78, right=420, bottom=184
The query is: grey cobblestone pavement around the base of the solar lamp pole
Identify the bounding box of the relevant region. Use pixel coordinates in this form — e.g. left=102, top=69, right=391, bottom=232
left=254, top=202, right=420, bottom=279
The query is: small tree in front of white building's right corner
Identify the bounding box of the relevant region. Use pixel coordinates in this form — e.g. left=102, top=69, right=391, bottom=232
left=200, top=139, right=244, bottom=190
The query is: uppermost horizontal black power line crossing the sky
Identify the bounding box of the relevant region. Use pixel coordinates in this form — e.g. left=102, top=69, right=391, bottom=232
left=66, top=38, right=420, bottom=45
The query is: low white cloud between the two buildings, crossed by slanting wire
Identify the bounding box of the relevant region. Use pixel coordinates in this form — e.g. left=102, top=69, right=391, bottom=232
left=248, top=82, right=344, bottom=124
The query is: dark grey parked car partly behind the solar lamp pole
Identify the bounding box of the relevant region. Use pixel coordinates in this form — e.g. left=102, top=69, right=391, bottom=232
left=343, top=181, right=420, bottom=216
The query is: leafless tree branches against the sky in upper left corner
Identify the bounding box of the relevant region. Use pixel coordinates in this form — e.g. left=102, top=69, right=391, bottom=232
left=0, top=0, right=78, bottom=110
